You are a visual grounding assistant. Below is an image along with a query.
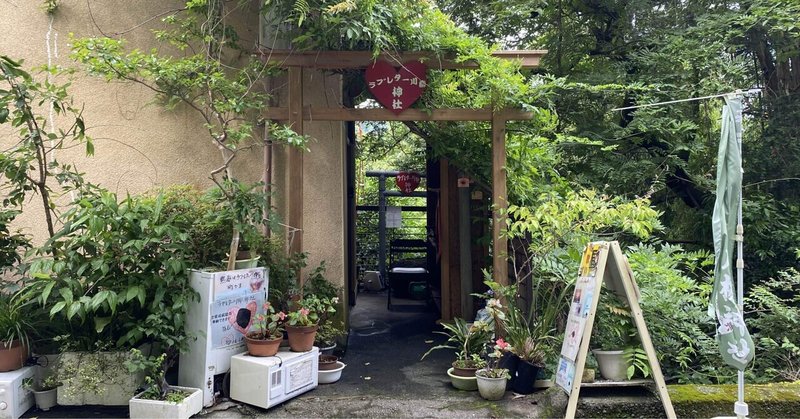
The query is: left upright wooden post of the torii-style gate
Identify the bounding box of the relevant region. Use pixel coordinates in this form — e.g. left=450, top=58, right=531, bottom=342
left=286, top=67, right=304, bottom=253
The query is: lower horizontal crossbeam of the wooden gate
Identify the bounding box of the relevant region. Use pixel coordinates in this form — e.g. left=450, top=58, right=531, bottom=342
left=264, top=106, right=533, bottom=121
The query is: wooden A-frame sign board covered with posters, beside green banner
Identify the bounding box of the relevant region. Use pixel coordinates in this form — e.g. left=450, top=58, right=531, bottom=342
left=556, top=241, right=675, bottom=419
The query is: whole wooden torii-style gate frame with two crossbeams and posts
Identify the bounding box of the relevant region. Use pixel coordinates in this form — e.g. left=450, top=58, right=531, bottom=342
left=260, top=50, right=547, bottom=315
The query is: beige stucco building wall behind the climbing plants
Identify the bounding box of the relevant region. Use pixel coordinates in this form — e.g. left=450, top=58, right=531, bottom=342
left=0, top=0, right=346, bottom=294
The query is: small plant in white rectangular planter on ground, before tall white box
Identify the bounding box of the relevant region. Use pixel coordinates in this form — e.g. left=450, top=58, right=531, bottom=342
left=126, top=349, right=203, bottom=419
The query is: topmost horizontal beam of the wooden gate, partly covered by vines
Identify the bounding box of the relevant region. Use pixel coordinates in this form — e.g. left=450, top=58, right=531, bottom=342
left=258, top=49, right=547, bottom=70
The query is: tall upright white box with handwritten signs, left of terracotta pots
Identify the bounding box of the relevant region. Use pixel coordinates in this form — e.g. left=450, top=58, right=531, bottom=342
left=178, top=268, right=269, bottom=406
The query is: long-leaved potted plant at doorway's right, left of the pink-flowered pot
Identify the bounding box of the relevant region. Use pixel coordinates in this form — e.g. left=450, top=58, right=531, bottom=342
left=422, top=317, right=493, bottom=378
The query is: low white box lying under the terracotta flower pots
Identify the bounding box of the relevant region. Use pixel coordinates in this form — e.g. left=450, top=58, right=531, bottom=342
left=231, top=346, right=319, bottom=409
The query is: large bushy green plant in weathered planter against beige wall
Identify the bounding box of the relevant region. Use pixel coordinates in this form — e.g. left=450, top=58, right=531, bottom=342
left=19, top=189, right=197, bottom=405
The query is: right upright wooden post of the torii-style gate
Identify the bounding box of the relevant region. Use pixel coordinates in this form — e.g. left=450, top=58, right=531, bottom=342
left=492, top=113, right=508, bottom=285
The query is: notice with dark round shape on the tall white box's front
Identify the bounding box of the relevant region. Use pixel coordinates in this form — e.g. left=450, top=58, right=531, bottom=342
left=209, top=292, right=266, bottom=349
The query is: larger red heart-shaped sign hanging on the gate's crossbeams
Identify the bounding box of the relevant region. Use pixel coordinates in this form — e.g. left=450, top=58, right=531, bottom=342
left=364, top=60, right=428, bottom=115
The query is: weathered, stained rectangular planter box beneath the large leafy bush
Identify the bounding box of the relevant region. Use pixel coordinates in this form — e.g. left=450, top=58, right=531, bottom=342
left=58, top=351, right=144, bottom=406
